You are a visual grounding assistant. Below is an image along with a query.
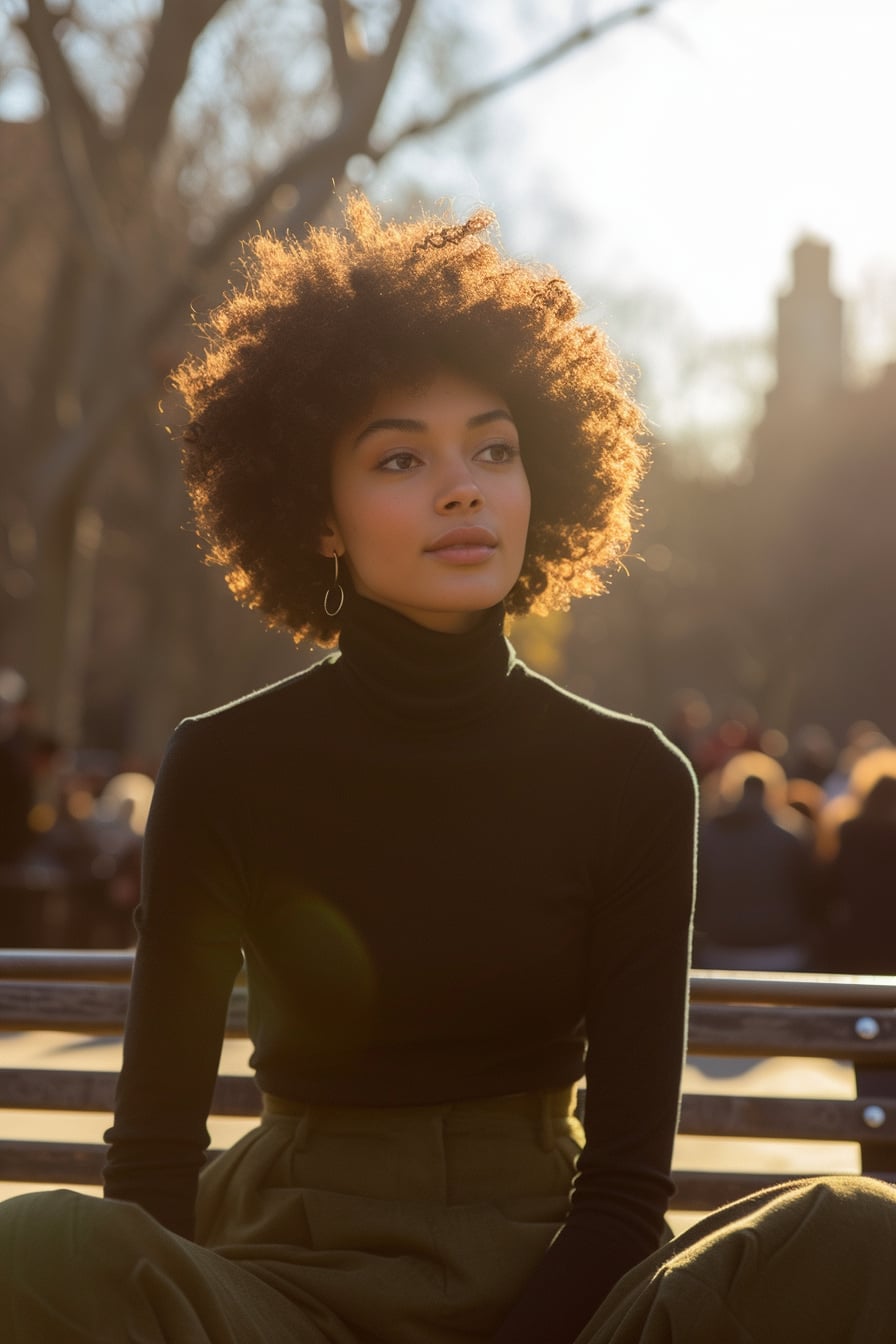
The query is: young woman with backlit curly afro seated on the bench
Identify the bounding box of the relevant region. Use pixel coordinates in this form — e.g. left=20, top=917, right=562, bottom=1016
left=0, top=200, right=896, bottom=1344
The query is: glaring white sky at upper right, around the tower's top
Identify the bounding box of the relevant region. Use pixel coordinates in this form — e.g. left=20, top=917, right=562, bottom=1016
left=376, top=0, right=896, bottom=379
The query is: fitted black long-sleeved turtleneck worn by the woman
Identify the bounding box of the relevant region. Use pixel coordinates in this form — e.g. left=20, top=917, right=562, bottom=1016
left=106, top=597, right=695, bottom=1344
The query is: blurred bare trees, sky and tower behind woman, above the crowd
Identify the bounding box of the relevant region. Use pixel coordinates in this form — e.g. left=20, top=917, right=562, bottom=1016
left=0, top=0, right=896, bottom=771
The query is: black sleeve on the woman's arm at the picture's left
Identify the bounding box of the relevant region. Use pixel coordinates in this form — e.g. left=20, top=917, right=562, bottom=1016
left=103, top=722, right=240, bottom=1236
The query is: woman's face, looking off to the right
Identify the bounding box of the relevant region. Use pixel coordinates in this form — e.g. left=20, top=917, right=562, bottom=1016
left=321, top=372, right=529, bottom=632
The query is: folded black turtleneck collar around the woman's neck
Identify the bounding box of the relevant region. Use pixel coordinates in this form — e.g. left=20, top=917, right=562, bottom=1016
left=337, top=591, right=514, bottom=726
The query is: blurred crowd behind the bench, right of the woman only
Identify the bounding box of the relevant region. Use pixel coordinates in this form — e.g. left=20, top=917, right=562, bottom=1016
left=669, top=692, right=896, bottom=974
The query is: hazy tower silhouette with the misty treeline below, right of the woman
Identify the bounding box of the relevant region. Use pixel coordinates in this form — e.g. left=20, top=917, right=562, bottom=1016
left=564, top=238, right=896, bottom=738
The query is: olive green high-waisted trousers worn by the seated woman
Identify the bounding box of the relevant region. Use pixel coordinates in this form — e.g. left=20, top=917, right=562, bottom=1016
left=0, top=1093, right=896, bottom=1344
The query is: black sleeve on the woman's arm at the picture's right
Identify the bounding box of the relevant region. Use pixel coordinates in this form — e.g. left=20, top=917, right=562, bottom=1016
left=496, top=738, right=696, bottom=1344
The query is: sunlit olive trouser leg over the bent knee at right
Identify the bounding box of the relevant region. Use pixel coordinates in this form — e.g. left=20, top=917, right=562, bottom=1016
left=575, top=1176, right=896, bottom=1344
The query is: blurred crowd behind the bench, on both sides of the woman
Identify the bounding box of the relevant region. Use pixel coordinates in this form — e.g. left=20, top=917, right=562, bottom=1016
left=0, top=668, right=896, bottom=974
